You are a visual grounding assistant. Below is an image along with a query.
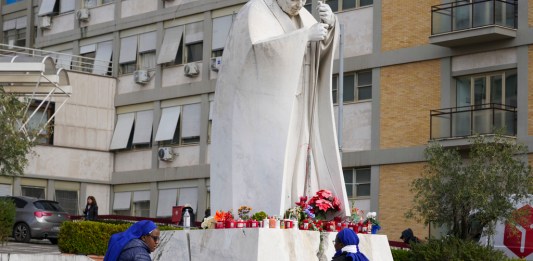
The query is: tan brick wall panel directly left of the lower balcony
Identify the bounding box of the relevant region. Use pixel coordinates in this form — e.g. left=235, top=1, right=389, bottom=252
left=380, top=60, right=440, bottom=149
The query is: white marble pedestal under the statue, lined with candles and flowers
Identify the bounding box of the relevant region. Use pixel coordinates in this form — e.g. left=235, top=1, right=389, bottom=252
left=152, top=228, right=393, bottom=261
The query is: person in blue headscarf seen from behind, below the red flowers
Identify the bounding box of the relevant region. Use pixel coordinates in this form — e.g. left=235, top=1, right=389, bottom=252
left=332, top=228, right=368, bottom=261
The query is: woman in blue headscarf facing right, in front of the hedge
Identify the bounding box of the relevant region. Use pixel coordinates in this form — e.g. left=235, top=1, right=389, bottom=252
left=104, top=220, right=160, bottom=261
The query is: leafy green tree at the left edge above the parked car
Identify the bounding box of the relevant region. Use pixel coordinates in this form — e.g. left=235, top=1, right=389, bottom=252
left=0, top=87, right=34, bottom=176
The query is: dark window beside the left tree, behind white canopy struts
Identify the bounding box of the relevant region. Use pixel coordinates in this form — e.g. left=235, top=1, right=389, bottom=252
left=26, top=100, right=55, bottom=145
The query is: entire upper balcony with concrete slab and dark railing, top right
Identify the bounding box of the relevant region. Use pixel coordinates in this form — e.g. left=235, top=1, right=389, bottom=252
left=429, top=0, right=518, bottom=47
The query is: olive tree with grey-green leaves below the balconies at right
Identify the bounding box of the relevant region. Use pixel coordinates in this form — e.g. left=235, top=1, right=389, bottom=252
left=406, top=134, right=533, bottom=239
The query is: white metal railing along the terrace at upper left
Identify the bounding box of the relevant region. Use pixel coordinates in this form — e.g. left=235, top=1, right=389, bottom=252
left=0, top=44, right=113, bottom=76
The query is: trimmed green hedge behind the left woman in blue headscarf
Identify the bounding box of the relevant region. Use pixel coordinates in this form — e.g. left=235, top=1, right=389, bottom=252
left=57, top=221, right=178, bottom=255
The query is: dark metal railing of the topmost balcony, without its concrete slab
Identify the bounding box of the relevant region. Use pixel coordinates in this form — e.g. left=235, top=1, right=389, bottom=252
left=431, top=0, right=518, bottom=35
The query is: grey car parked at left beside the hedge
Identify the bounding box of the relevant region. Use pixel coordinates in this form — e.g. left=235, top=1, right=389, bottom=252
left=0, top=196, right=69, bottom=244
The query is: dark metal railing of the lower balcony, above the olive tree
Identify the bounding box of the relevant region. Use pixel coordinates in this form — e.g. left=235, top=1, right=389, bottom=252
left=430, top=103, right=517, bottom=140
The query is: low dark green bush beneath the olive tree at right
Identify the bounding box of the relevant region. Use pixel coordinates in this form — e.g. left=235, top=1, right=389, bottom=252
left=410, top=237, right=509, bottom=261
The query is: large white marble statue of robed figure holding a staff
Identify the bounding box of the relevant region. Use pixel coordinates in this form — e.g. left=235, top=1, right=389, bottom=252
left=210, top=0, right=349, bottom=215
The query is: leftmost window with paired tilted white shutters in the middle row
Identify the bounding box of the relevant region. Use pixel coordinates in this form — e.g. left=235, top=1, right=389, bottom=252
left=109, top=110, right=153, bottom=150
